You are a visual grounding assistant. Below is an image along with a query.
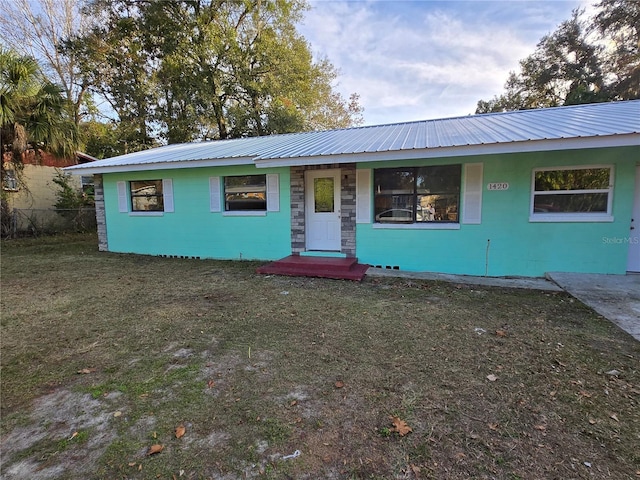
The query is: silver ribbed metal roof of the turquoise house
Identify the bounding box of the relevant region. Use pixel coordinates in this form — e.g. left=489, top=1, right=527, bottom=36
left=69, top=100, right=640, bottom=170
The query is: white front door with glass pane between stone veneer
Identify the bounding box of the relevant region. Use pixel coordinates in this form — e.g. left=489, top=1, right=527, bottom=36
left=305, top=169, right=341, bottom=252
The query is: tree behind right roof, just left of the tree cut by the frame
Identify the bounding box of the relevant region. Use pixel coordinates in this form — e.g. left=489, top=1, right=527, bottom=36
left=476, top=10, right=611, bottom=113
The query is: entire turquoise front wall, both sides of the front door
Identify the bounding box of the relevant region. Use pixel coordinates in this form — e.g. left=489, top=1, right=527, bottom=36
left=103, top=147, right=640, bottom=277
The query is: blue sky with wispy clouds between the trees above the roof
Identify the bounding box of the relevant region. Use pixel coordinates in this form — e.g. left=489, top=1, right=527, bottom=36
left=298, top=0, right=590, bottom=125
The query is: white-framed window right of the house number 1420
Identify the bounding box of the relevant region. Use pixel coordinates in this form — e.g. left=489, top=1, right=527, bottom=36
left=531, top=167, right=612, bottom=220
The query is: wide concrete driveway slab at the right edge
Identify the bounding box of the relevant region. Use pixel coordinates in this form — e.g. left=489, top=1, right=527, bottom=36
left=547, top=272, right=640, bottom=340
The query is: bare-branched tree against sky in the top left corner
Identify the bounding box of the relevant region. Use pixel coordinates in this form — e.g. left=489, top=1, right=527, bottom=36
left=0, top=0, right=89, bottom=126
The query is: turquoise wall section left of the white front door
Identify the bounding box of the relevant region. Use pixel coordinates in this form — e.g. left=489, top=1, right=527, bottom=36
left=103, top=166, right=291, bottom=260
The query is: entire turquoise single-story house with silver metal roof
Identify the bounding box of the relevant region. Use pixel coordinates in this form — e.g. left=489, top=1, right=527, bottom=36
left=67, top=101, right=640, bottom=276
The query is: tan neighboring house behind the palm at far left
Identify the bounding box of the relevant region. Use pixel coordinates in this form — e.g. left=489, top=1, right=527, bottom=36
left=2, top=150, right=96, bottom=210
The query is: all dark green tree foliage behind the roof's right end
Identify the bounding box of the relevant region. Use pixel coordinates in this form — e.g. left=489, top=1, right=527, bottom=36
left=476, top=0, right=640, bottom=113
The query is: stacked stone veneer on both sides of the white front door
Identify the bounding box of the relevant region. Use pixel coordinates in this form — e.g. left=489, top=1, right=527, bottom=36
left=291, top=164, right=356, bottom=257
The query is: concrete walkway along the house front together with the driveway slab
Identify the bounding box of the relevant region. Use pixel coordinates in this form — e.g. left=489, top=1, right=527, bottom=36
left=367, top=267, right=640, bottom=340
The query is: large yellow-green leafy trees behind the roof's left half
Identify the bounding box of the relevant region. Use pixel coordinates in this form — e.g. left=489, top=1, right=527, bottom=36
left=65, top=0, right=362, bottom=151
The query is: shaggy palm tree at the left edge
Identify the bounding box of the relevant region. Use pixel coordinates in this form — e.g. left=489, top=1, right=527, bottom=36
left=0, top=47, right=79, bottom=164
